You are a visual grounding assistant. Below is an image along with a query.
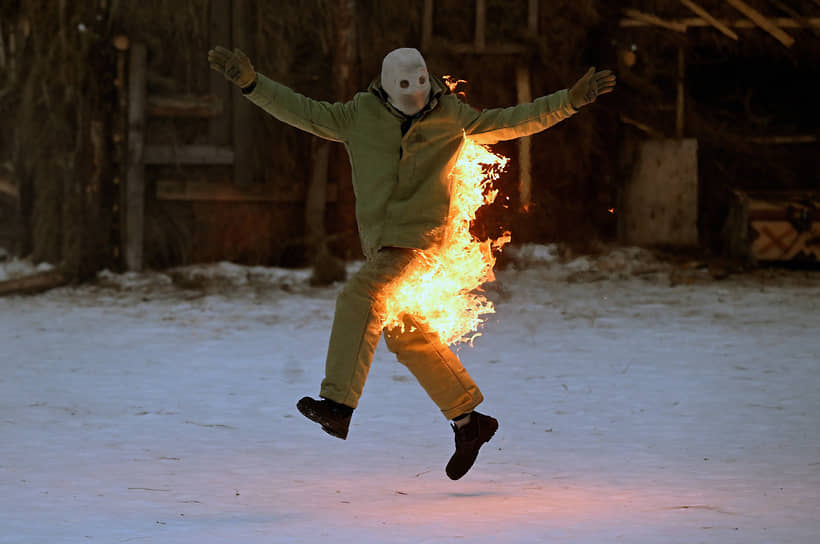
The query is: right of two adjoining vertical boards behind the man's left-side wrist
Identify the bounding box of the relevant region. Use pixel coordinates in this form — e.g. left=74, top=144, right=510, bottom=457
left=231, top=0, right=256, bottom=185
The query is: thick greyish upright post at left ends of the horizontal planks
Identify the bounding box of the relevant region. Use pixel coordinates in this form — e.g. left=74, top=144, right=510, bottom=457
left=122, top=43, right=147, bottom=271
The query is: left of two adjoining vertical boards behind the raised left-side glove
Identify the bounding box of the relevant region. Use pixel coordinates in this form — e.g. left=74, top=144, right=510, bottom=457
left=208, top=0, right=233, bottom=145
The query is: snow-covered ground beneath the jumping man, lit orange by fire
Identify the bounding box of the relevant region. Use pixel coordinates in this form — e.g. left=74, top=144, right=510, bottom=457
left=0, top=246, right=820, bottom=544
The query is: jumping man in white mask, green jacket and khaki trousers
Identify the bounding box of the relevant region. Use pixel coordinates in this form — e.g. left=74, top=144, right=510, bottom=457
left=208, top=46, right=615, bottom=480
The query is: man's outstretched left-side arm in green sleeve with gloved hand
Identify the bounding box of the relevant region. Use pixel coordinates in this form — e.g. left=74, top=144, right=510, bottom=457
left=208, top=46, right=353, bottom=141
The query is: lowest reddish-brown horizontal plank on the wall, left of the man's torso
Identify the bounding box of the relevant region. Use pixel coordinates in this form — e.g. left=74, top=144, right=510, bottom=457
left=156, top=179, right=338, bottom=204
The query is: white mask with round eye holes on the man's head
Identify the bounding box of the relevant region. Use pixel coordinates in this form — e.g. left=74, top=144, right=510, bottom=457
left=381, top=47, right=430, bottom=115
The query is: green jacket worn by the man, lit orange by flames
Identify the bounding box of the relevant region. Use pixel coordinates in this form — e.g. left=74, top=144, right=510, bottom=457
left=245, top=74, right=576, bottom=256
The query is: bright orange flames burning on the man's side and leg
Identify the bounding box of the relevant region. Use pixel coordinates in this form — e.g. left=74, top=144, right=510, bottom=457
left=382, top=137, right=510, bottom=345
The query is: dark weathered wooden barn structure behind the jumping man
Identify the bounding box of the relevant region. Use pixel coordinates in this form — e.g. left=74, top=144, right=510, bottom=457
left=0, top=0, right=820, bottom=288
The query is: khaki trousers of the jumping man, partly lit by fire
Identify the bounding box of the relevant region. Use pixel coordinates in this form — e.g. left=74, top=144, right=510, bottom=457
left=319, top=247, right=483, bottom=419
